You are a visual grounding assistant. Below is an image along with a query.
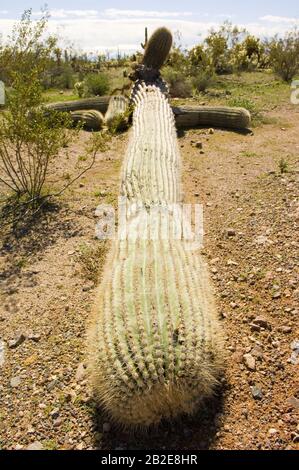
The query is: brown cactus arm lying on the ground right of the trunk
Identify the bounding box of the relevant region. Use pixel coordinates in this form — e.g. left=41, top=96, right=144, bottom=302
left=172, top=106, right=251, bottom=129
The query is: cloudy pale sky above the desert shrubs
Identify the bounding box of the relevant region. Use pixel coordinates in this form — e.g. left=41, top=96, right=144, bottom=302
left=0, top=0, right=299, bottom=52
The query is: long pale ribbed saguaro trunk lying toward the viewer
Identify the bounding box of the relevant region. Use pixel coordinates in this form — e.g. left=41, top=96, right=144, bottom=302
left=91, top=86, right=223, bottom=426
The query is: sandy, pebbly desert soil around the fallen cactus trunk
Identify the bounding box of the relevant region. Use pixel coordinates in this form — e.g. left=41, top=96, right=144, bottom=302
left=0, top=106, right=299, bottom=449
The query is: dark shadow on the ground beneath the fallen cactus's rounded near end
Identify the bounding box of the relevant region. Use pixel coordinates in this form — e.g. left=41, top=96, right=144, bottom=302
left=93, top=386, right=225, bottom=450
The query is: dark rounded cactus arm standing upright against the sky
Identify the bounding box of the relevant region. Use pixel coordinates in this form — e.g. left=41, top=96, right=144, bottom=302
left=142, top=28, right=172, bottom=70
